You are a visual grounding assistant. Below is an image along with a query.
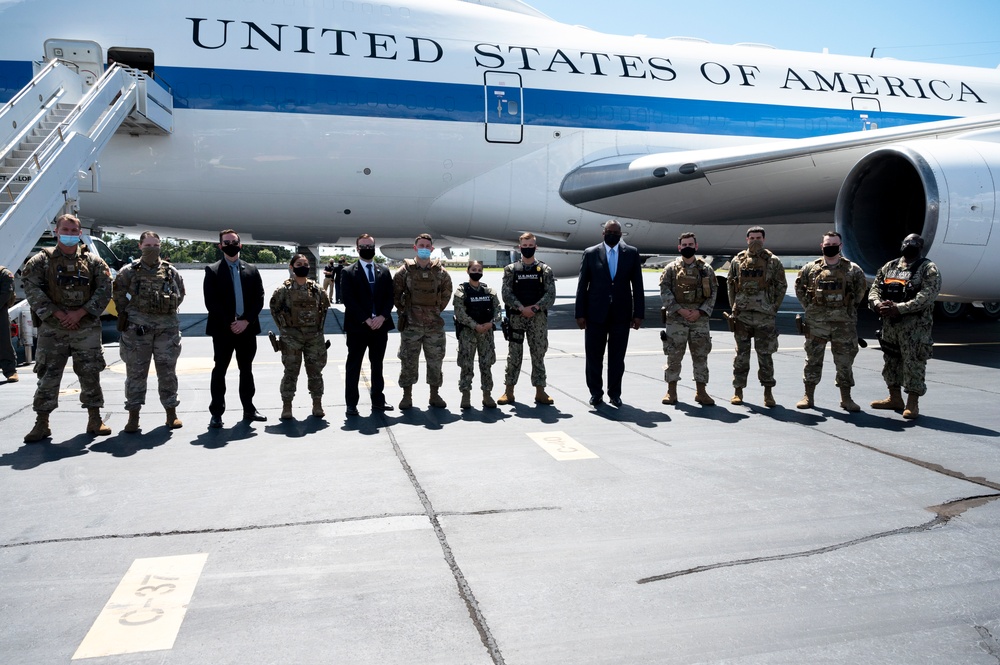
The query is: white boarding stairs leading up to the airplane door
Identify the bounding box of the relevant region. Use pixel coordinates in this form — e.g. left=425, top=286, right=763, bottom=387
left=0, top=60, right=173, bottom=270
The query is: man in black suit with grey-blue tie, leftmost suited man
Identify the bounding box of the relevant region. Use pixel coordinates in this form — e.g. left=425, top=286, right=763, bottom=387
left=205, top=229, right=267, bottom=427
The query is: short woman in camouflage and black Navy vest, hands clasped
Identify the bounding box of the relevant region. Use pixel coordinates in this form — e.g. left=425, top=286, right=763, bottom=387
left=452, top=261, right=500, bottom=409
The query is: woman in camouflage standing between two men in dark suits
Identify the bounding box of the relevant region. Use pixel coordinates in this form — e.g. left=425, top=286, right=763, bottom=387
left=270, top=254, right=330, bottom=420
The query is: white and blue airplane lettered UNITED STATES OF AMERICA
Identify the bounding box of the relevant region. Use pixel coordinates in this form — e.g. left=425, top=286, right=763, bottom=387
left=0, top=0, right=1000, bottom=319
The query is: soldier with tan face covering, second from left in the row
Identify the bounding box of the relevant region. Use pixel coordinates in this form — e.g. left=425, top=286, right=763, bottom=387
left=113, top=231, right=185, bottom=433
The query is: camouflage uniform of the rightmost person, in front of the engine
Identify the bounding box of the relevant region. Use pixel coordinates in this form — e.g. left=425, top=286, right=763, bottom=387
left=868, top=259, right=941, bottom=396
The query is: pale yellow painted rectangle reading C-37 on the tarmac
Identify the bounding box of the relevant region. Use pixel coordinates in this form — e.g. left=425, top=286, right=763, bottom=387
left=72, top=554, right=208, bottom=660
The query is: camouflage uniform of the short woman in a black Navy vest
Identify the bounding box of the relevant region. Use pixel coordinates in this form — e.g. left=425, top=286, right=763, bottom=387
left=452, top=282, right=500, bottom=392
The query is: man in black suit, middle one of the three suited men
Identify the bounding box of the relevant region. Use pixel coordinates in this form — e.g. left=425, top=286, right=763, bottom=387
left=340, top=233, right=394, bottom=416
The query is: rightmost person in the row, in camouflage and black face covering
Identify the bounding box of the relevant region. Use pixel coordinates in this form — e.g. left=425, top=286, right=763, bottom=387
left=868, top=233, right=941, bottom=419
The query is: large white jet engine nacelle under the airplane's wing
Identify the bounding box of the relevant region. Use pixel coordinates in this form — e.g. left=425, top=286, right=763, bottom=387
left=835, top=140, right=1000, bottom=301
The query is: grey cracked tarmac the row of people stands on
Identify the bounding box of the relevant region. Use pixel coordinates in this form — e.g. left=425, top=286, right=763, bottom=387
left=0, top=270, right=1000, bottom=665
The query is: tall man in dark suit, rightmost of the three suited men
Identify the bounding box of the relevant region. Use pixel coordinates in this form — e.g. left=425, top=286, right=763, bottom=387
left=576, top=219, right=646, bottom=407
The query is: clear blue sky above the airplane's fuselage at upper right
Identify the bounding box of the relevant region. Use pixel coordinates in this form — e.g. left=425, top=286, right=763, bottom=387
left=525, top=0, right=1000, bottom=68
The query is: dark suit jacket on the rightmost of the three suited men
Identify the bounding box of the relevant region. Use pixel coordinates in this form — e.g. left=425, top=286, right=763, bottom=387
left=576, top=242, right=646, bottom=323
